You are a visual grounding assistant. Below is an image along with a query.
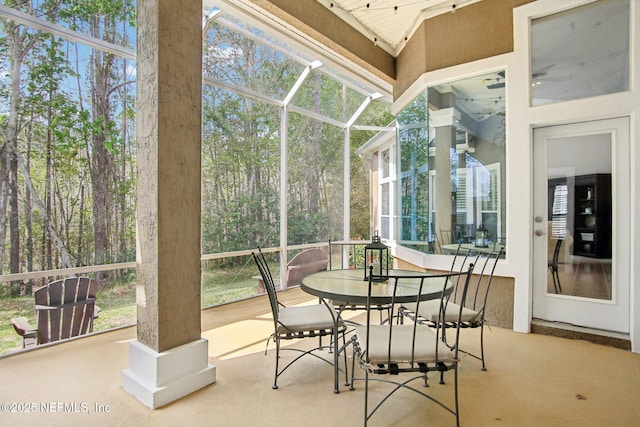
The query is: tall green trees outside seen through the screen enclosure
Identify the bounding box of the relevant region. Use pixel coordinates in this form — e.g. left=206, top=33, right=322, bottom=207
left=0, top=4, right=390, bottom=325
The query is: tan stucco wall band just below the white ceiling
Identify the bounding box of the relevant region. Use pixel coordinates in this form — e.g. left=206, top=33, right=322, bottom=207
left=251, top=0, right=535, bottom=98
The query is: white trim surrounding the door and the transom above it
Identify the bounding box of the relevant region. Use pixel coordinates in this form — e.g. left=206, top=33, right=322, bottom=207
left=510, top=0, right=640, bottom=354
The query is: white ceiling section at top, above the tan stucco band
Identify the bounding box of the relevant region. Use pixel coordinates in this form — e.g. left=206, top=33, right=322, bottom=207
left=317, top=0, right=480, bottom=56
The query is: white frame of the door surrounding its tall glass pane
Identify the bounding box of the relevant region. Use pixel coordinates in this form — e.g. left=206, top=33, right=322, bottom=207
left=532, top=117, right=631, bottom=334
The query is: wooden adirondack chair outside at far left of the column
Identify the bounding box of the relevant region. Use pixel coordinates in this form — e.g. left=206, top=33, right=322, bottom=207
left=12, top=277, right=98, bottom=348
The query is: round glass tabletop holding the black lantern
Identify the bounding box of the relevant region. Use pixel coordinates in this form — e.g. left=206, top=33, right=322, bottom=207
left=300, top=269, right=451, bottom=304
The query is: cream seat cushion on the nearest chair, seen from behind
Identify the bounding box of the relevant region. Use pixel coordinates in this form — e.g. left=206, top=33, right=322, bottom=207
left=355, top=324, right=451, bottom=365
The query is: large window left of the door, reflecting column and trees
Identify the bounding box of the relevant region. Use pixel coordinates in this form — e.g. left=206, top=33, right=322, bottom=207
left=396, top=71, right=506, bottom=253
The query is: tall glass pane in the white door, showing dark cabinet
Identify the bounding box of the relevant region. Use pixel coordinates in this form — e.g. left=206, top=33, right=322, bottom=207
left=547, top=134, right=613, bottom=300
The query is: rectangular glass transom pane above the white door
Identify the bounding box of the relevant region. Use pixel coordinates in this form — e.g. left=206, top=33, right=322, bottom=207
left=531, top=0, right=630, bottom=106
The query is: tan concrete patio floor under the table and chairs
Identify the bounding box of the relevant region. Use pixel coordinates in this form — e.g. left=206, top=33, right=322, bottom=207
left=0, top=289, right=640, bottom=427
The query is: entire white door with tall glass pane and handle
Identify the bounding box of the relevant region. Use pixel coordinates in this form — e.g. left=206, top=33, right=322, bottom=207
left=533, top=118, right=631, bottom=333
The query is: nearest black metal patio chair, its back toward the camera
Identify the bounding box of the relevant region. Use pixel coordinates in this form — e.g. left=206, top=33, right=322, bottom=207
left=351, top=265, right=473, bottom=426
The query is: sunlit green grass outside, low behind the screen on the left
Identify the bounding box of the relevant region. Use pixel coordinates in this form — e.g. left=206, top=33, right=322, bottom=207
left=0, top=266, right=258, bottom=355
